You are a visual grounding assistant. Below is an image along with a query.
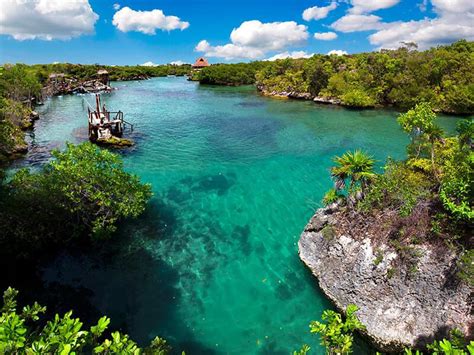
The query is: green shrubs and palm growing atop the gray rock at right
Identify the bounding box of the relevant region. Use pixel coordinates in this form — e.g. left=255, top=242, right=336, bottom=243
left=323, top=102, right=474, bottom=284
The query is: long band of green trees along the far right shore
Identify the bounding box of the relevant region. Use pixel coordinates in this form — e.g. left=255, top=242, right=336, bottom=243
left=198, top=40, right=474, bottom=114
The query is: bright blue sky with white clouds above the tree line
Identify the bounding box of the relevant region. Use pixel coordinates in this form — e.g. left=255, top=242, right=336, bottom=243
left=0, top=0, right=474, bottom=65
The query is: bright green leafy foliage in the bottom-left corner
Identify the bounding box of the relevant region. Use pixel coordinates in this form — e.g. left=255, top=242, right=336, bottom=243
left=0, top=288, right=171, bottom=355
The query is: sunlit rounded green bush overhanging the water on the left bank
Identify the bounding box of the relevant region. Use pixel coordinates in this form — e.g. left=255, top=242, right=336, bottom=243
left=11, top=142, right=151, bottom=236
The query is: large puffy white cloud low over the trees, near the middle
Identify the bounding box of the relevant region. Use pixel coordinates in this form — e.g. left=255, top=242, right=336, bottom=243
left=195, top=20, right=309, bottom=59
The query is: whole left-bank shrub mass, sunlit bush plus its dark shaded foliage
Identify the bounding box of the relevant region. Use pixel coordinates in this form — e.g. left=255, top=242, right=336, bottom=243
left=0, top=142, right=151, bottom=257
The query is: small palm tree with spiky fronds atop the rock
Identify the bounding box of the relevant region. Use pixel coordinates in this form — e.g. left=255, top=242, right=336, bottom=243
left=331, top=150, right=375, bottom=194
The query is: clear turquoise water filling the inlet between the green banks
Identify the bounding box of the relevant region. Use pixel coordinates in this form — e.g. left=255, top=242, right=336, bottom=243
left=19, top=78, right=462, bottom=354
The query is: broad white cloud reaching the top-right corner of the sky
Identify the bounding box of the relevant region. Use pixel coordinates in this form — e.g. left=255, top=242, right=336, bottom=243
left=369, top=0, right=474, bottom=49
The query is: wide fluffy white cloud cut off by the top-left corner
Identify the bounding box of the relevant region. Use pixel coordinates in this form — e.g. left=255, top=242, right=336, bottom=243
left=0, top=0, right=99, bottom=40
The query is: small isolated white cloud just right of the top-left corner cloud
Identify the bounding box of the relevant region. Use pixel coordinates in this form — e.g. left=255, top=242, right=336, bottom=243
left=113, top=7, right=189, bottom=35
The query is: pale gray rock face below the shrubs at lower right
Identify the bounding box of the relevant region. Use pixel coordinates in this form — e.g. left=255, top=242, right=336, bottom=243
left=298, top=208, right=474, bottom=351
